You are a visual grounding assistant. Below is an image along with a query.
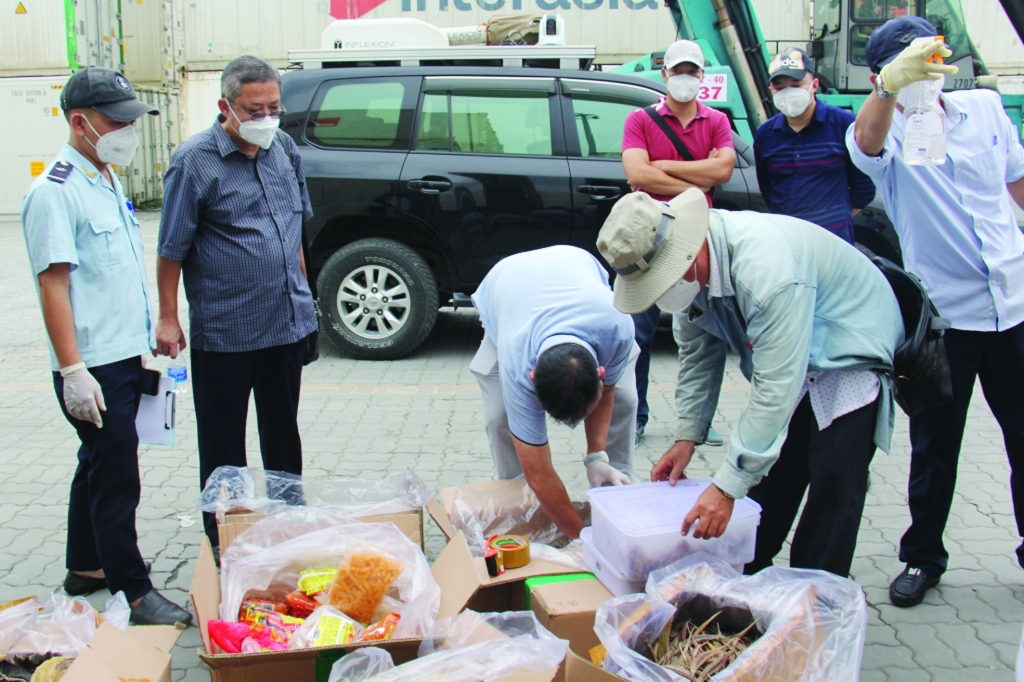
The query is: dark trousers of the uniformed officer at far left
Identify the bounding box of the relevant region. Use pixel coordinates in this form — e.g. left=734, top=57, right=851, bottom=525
left=53, top=356, right=153, bottom=602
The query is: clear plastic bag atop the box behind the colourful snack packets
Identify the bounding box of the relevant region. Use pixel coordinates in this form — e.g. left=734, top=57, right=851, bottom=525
left=196, top=466, right=430, bottom=516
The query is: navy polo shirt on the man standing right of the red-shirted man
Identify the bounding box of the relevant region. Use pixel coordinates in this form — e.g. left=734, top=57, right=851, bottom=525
left=754, top=100, right=874, bottom=244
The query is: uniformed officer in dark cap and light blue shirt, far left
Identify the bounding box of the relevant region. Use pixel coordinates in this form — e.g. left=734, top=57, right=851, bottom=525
left=22, top=67, right=191, bottom=625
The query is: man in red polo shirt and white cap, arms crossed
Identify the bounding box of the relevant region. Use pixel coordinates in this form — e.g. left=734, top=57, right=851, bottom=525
left=623, top=40, right=736, bottom=445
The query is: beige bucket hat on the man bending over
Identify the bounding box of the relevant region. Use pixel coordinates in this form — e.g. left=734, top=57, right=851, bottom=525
left=597, top=187, right=709, bottom=313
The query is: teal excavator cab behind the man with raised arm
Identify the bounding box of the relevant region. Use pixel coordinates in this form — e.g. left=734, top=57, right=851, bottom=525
left=808, top=0, right=994, bottom=93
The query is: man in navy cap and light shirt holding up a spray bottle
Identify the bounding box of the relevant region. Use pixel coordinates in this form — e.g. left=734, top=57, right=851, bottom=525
left=846, top=16, right=1024, bottom=606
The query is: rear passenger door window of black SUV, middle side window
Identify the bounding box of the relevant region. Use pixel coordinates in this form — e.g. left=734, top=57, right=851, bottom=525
left=416, top=90, right=551, bottom=156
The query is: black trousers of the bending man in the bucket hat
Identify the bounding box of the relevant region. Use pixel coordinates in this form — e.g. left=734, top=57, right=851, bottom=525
left=743, top=395, right=879, bottom=578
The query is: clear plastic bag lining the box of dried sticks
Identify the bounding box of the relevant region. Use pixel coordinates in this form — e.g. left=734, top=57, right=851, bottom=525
left=594, top=553, right=867, bottom=682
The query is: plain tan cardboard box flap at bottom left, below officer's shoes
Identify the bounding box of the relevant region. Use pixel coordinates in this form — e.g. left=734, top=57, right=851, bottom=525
left=60, top=623, right=184, bottom=682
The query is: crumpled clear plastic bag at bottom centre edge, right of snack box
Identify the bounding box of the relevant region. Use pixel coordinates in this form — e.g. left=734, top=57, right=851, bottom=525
left=328, top=610, right=569, bottom=682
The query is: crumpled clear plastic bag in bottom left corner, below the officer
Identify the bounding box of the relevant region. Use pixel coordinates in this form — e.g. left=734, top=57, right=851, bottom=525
left=0, top=593, right=97, bottom=656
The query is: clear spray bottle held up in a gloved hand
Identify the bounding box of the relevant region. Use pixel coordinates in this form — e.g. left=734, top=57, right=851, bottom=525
left=903, top=36, right=946, bottom=166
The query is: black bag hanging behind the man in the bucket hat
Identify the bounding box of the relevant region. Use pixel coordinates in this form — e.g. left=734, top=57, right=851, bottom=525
left=871, top=256, right=953, bottom=417
